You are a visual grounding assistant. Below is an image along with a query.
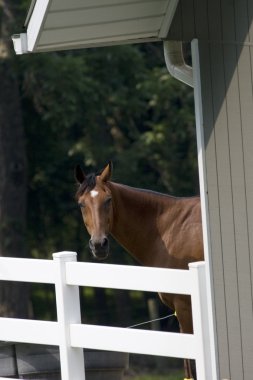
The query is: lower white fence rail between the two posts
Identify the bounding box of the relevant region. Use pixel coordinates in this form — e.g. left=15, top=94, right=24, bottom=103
left=70, top=324, right=198, bottom=359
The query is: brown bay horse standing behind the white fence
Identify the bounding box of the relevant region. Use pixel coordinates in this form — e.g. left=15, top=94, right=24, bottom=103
left=75, top=163, right=203, bottom=379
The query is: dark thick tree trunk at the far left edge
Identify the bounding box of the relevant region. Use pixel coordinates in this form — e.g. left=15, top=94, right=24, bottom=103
left=0, top=0, right=29, bottom=317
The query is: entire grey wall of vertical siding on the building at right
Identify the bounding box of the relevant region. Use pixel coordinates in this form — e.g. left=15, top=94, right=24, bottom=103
left=169, top=0, right=253, bottom=380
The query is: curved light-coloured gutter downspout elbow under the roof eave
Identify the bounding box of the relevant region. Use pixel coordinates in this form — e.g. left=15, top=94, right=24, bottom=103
left=163, top=41, right=193, bottom=87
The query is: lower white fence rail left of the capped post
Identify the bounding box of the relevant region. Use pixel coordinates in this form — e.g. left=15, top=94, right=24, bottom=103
left=0, top=318, right=60, bottom=345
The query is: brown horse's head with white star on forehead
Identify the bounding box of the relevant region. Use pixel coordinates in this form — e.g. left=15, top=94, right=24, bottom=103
left=75, top=163, right=113, bottom=260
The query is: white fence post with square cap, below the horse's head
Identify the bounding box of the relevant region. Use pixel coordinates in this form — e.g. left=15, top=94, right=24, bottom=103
left=53, top=252, right=85, bottom=380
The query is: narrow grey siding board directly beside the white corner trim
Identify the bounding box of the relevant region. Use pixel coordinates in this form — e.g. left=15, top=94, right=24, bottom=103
left=199, top=43, right=229, bottom=374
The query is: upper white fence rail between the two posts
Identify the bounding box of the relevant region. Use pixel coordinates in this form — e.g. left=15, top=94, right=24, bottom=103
left=66, top=262, right=193, bottom=294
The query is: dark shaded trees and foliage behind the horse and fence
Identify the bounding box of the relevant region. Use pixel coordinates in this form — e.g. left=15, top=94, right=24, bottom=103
left=0, top=0, right=198, bottom=338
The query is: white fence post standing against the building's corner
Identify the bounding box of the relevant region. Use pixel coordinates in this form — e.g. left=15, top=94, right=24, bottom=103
left=189, top=262, right=217, bottom=380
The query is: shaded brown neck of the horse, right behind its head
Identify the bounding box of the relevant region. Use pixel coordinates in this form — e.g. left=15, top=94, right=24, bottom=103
left=109, top=182, right=174, bottom=266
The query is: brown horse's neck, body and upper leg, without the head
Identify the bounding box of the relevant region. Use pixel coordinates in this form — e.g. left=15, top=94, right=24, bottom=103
left=108, top=182, right=203, bottom=333
